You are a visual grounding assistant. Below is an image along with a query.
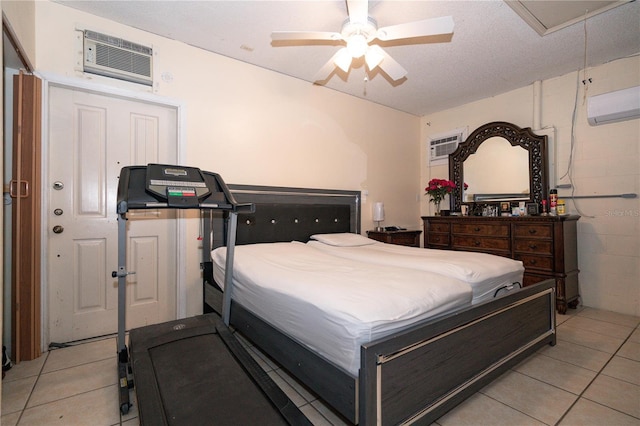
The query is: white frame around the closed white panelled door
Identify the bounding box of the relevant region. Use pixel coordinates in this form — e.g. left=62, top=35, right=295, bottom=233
left=39, top=72, right=187, bottom=351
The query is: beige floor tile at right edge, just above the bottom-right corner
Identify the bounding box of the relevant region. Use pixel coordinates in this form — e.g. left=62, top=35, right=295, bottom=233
left=583, top=375, right=640, bottom=418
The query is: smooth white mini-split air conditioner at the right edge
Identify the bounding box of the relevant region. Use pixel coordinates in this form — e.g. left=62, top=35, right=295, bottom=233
left=587, top=86, right=640, bottom=126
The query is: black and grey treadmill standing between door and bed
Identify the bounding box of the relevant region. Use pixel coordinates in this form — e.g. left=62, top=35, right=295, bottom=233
left=112, top=164, right=311, bottom=425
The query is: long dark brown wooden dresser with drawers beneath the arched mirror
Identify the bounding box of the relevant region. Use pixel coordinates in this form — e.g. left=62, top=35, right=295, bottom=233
left=422, top=216, right=580, bottom=314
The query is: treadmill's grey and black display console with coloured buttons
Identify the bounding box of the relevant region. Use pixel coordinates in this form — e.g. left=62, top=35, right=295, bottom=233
left=146, top=164, right=211, bottom=208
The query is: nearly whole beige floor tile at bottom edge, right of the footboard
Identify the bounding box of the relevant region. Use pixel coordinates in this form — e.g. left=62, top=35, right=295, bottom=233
left=481, top=371, right=578, bottom=425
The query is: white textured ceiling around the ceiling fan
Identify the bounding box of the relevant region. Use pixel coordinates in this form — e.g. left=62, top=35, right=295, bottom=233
left=56, top=0, right=640, bottom=116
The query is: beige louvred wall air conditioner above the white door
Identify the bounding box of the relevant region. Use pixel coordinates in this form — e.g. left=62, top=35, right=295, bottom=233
left=83, top=30, right=153, bottom=86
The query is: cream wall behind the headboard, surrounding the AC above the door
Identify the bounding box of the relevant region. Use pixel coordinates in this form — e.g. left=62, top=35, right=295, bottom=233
left=8, top=1, right=420, bottom=315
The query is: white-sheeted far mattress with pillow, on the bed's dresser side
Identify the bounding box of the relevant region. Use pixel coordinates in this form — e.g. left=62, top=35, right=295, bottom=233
left=307, top=234, right=524, bottom=304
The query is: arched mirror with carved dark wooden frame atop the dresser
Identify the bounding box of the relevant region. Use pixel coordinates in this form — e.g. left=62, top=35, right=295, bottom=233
left=449, top=122, right=547, bottom=211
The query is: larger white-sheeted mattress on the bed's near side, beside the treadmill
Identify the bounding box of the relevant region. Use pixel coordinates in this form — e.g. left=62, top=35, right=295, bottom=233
left=211, top=242, right=472, bottom=377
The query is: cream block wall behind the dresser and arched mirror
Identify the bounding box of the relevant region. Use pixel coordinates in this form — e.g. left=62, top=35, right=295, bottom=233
left=421, top=56, right=640, bottom=316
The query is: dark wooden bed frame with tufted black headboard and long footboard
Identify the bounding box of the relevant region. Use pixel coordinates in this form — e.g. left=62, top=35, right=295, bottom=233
left=203, top=185, right=556, bottom=425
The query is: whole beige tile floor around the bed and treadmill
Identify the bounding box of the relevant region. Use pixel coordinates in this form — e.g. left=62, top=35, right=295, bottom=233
left=0, top=308, right=640, bottom=426
